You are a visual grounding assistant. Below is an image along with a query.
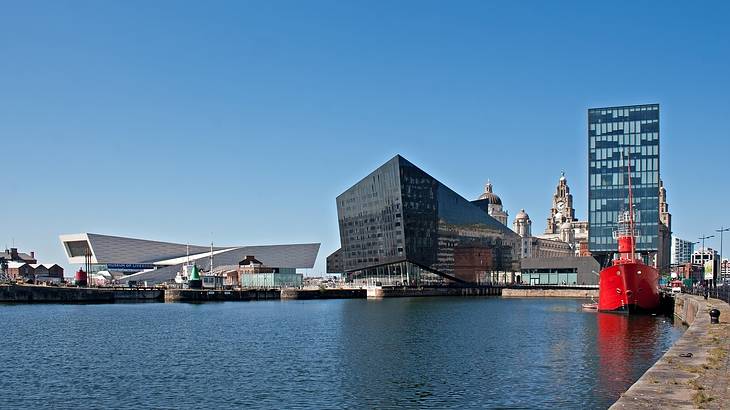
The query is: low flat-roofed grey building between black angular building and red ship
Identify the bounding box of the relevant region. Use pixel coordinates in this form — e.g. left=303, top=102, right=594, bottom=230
left=520, top=255, right=601, bottom=286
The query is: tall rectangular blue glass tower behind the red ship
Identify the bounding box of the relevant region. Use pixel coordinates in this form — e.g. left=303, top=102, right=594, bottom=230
left=588, top=104, right=659, bottom=266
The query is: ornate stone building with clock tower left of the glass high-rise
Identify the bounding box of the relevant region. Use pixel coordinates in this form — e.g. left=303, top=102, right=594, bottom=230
left=539, top=172, right=589, bottom=256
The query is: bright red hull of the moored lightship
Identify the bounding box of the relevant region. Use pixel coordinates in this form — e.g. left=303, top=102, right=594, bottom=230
left=598, top=262, right=660, bottom=314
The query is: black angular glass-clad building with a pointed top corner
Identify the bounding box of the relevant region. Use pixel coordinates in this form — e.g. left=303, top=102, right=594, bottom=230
left=328, top=155, right=520, bottom=286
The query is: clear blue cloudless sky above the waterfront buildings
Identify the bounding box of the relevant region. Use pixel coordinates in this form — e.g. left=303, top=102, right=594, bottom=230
left=0, top=1, right=730, bottom=272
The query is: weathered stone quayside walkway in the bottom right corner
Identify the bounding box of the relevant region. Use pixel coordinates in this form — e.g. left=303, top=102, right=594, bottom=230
left=611, top=294, right=730, bottom=409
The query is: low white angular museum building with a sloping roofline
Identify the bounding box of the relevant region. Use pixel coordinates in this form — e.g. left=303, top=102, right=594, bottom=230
left=60, top=233, right=320, bottom=284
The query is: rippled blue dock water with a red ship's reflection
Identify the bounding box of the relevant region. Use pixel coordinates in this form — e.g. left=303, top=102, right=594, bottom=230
left=0, top=298, right=683, bottom=408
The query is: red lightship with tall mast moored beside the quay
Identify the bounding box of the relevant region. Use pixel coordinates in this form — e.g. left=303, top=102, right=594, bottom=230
left=598, top=152, right=659, bottom=313
